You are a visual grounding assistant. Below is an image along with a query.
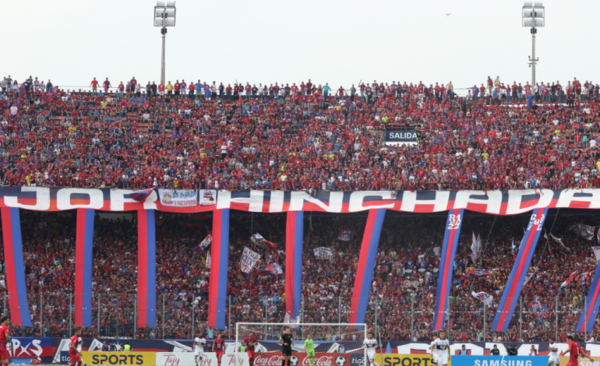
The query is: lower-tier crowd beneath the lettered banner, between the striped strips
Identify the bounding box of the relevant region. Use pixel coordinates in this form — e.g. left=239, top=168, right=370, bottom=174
left=0, top=211, right=600, bottom=342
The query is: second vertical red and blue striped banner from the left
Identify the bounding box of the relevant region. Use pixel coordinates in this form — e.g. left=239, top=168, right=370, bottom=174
left=74, top=208, right=95, bottom=327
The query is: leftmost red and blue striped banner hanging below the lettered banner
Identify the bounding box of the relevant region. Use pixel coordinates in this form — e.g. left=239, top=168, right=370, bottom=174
left=2, top=207, right=31, bottom=327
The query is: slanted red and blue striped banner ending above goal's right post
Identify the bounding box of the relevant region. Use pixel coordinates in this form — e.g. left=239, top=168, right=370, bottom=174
left=350, top=209, right=386, bottom=323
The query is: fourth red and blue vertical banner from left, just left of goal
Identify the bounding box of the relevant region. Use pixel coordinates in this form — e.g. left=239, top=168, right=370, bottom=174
left=208, top=209, right=229, bottom=329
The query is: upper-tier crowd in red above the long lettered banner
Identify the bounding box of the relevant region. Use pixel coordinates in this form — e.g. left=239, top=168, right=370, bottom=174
left=0, top=76, right=600, bottom=191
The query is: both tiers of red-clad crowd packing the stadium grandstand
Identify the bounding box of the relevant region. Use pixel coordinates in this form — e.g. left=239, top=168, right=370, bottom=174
left=0, top=77, right=600, bottom=342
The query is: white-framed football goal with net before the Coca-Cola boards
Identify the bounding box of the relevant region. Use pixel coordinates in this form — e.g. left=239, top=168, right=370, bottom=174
left=235, top=322, right=368, bottom=366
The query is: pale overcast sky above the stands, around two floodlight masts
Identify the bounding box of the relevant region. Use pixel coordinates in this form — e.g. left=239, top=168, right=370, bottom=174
left=0, top=0, right=600, bottom=88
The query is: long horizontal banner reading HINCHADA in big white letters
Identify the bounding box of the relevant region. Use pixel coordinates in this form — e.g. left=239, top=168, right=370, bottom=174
left=8, top=186, right=600, bottom=213
